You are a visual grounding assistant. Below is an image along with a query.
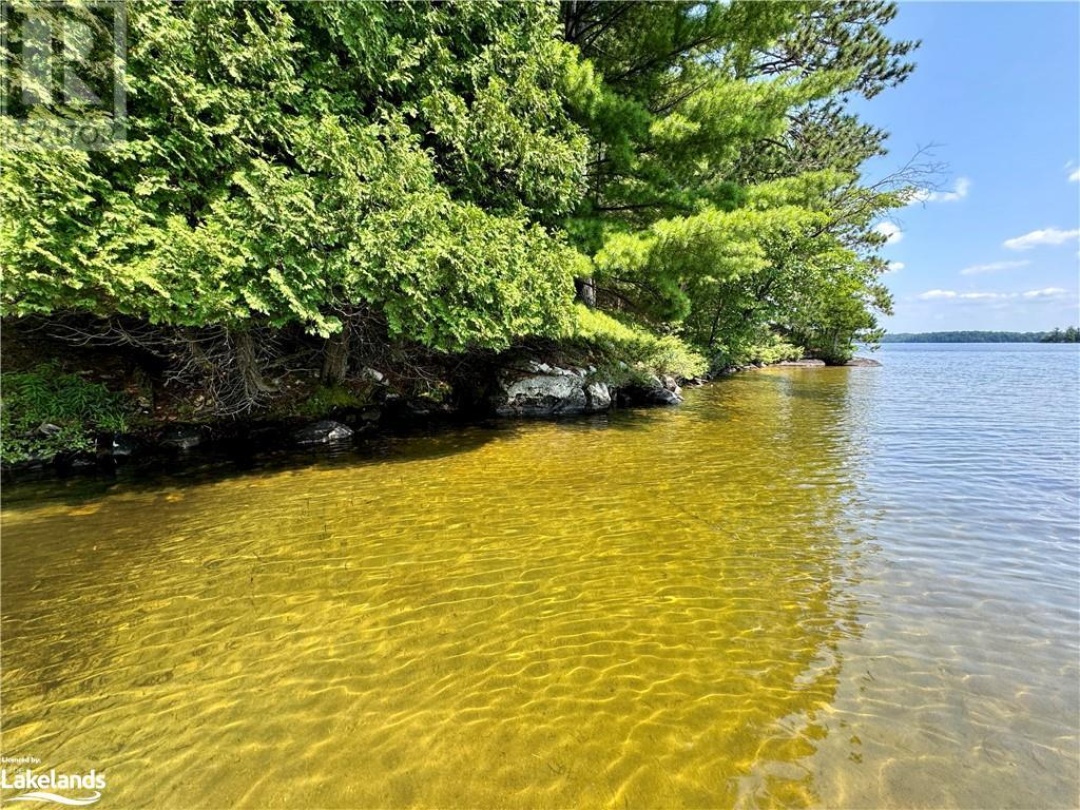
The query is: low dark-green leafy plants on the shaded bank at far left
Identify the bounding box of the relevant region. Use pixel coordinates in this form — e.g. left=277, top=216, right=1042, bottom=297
left=0, top=364, right=129, bottom=463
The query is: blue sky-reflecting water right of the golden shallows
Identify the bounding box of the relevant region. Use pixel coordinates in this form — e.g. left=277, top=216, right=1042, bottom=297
left=813, top=345, right=1080, bottom=808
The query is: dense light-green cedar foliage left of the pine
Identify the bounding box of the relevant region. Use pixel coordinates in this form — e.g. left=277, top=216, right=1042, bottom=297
left=0, top=2, right=585, bottom=351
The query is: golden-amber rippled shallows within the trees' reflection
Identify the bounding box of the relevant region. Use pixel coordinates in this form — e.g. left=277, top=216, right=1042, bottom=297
left=0, top=377, right=865, bottom=808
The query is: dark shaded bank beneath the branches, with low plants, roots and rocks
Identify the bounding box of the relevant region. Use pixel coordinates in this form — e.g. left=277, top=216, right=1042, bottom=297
left=0, top=349, right=881, bottom=483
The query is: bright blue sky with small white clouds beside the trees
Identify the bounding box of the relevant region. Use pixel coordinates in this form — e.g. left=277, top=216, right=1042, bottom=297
left=858, top=2, right=1080, bottom=332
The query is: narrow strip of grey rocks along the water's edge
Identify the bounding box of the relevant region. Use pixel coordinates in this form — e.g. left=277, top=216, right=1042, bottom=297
left=0, top=357, right=880, bottom=483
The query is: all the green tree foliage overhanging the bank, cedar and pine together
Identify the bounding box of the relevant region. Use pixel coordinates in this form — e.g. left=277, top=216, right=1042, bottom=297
left=0, top=0, right=917, bottom=403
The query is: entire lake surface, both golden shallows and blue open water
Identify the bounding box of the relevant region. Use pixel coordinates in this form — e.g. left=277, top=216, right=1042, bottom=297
left=0, top=345, right=1080, bottom=810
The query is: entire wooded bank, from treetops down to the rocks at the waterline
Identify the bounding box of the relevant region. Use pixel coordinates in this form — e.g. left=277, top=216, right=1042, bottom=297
left=0, top=0, right=924, bottom=467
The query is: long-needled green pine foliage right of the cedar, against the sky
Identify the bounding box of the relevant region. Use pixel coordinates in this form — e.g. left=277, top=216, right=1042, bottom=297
left=564, top=0, right=916, bottom=369
